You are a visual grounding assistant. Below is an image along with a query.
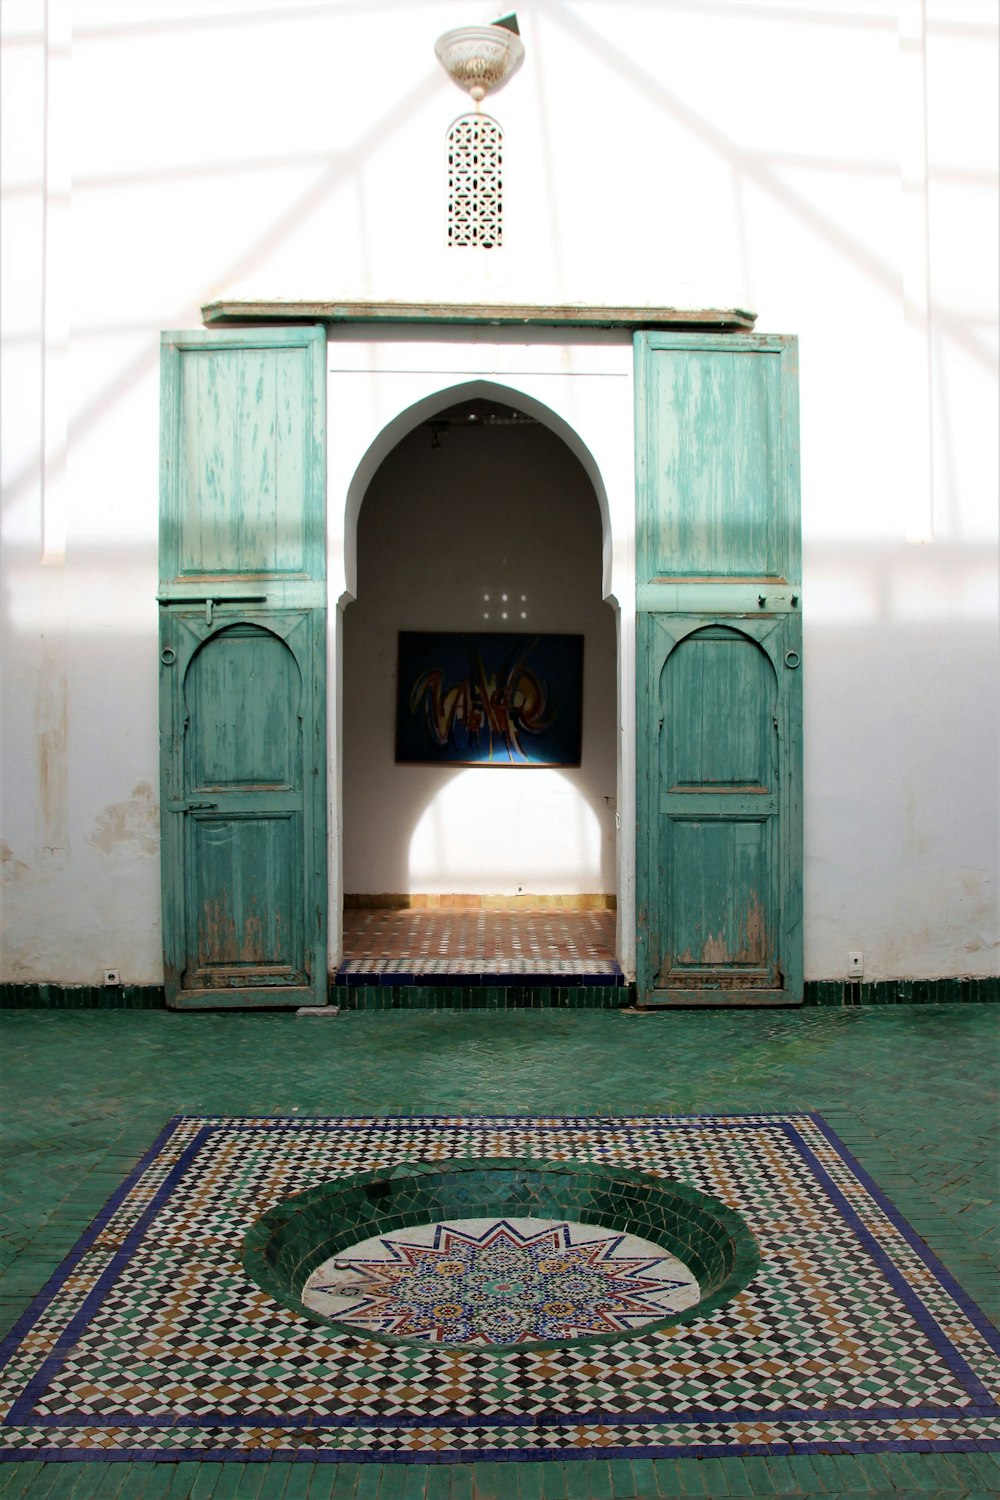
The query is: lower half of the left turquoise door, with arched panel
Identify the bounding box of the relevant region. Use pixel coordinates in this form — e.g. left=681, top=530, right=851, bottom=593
left=160, top=605, right=325, bottom=1005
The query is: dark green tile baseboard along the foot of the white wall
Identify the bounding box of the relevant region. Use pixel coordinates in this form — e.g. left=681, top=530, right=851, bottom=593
left=0, top=975, right=1000, bottom=1011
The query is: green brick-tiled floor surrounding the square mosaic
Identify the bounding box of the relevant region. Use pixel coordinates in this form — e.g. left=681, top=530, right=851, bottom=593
left=0, top=1005, right=1000, bottom=1500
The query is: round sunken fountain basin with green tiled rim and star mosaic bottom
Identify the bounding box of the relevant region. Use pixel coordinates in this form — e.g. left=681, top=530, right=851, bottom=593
left=243, top=1158, right=759, bottom=1350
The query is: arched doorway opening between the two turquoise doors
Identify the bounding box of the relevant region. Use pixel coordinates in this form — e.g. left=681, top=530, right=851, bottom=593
left=340, top=390, right=621, bottom=984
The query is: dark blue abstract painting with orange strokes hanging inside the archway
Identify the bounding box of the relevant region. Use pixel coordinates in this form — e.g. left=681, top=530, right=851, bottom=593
left=396, top=630, right=583, bottom=767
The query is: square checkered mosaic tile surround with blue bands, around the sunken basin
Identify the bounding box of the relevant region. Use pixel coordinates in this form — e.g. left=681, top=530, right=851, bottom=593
left=0, top=1113, right=1000, bottom=1463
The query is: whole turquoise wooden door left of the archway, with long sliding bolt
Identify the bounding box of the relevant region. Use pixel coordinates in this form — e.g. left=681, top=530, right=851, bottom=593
left=159, top=329, right=327, bottom=1007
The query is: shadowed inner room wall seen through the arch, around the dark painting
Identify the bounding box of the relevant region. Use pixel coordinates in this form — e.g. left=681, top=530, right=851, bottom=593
left=342, top=383, right=619, bottom=960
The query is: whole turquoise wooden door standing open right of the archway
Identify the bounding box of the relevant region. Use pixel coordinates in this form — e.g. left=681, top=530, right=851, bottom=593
left=636, top=335, right=802, bottom=1005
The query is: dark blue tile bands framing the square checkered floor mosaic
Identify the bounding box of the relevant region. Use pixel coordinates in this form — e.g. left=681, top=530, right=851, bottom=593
left=0, top=1112, right=1000, bottom=1464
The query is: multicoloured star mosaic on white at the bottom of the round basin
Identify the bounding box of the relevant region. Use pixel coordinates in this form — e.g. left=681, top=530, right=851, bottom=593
left=303, top=1218, right=699, bottom=1346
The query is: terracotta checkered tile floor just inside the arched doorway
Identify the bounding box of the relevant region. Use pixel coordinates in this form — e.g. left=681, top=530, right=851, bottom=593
left=339, top=908, right=621, bottom=977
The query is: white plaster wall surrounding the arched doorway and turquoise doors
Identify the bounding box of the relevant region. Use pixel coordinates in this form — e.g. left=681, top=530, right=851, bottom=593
left=0, top=0, right=1000, bottom=983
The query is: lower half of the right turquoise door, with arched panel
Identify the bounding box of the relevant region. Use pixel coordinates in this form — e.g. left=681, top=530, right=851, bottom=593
left=637, top=612, right=801, bottom=1004
